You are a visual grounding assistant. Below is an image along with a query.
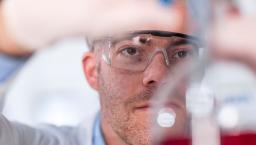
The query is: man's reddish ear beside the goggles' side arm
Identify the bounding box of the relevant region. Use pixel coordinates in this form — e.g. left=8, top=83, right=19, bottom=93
left=83, top=52, right=99, bottom=90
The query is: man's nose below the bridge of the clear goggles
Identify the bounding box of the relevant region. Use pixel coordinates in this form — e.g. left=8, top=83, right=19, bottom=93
left=143, top=52, right=168, bottom=86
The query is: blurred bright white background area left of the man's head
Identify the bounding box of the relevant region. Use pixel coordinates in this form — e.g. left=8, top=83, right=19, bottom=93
left=4, top=39, right=99, bottom=125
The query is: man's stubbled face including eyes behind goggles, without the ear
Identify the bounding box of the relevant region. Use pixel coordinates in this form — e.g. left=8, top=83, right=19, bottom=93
left=93, top=32, right=197, bottom=145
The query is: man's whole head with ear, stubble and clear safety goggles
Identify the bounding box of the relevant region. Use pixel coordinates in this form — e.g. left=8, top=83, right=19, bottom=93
left=83, top=2, right=199, bottom=145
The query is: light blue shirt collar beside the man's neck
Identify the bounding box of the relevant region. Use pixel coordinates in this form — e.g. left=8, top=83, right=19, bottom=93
left=92, top=114, right=106, bottom=145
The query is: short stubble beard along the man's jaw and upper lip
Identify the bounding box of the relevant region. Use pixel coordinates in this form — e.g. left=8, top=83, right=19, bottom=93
left=99, top=73, right=153, bottom=145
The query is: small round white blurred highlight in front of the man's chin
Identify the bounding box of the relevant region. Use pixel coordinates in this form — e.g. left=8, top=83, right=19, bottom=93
left=157, top=108, right=176, bottom=128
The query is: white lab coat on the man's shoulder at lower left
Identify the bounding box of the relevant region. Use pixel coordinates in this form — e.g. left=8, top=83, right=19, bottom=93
left=0, top=114, right=96, bottom=145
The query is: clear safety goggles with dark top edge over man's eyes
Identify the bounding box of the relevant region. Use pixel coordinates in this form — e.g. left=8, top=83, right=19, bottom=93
left=97, top=30, right=200, bottom=72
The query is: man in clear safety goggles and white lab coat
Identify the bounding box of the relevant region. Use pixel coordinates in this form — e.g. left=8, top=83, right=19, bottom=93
left=0, top=0, right=198, bottom=145
